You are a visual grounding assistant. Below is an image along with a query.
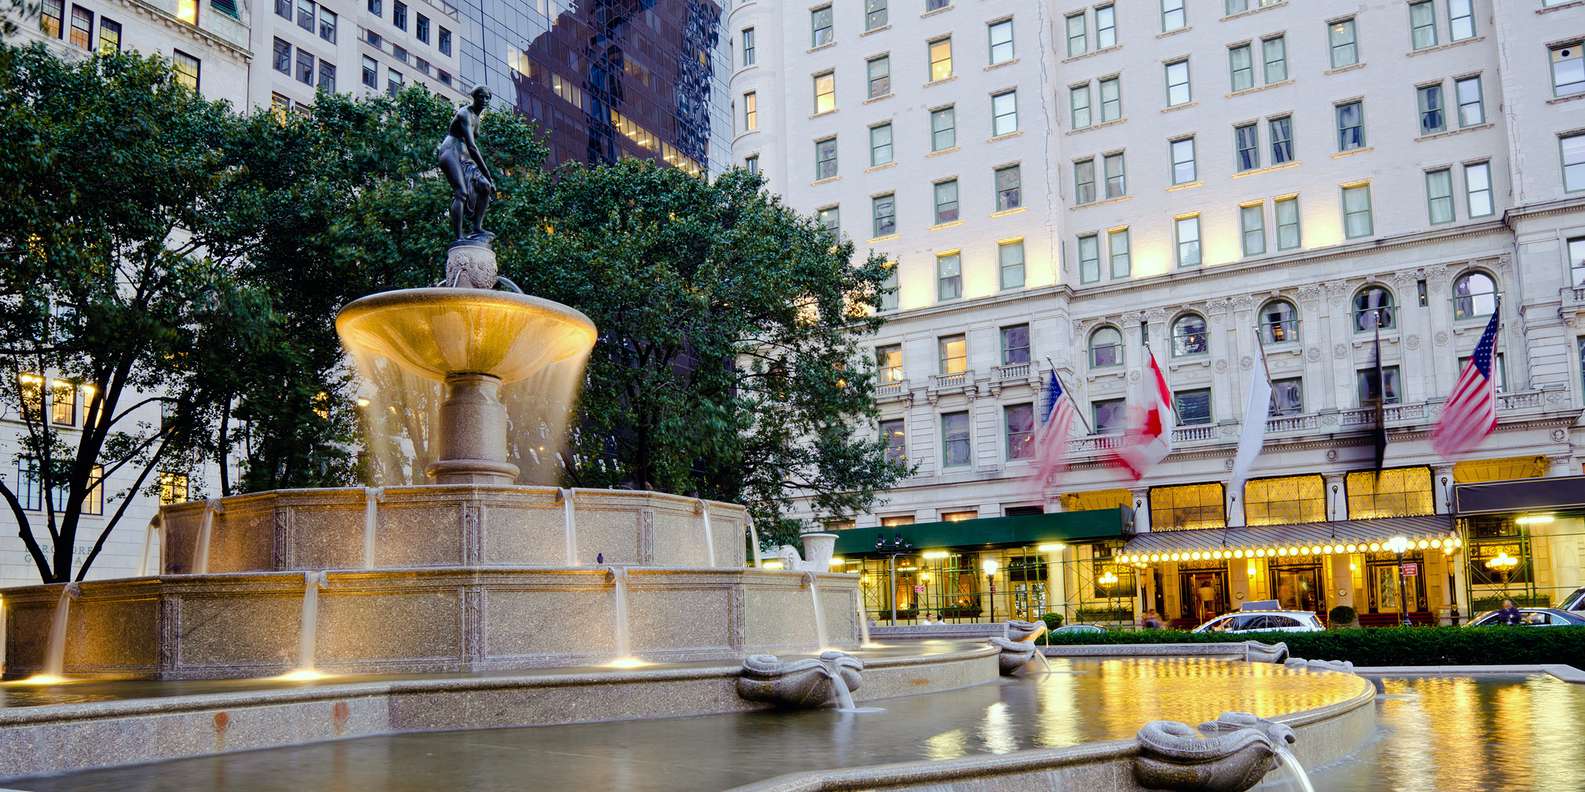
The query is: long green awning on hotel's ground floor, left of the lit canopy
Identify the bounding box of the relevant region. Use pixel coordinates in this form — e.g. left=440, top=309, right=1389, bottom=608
left=837, top=507, right=1133, bottom=556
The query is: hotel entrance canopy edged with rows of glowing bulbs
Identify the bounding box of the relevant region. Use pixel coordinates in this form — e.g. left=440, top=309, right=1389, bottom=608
left=1116, top=515, right=1458, bottom=564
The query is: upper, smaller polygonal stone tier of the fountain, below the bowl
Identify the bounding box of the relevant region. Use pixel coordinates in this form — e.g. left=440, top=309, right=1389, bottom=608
left=151, top=485, right=748, bottom=575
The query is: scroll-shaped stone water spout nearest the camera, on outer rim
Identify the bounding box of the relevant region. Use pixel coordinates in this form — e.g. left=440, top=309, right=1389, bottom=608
left=1133, top=713, right=1295, bottom=792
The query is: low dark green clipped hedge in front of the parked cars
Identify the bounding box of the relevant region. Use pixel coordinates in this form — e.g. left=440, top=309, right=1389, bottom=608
left=1051, top=627, right=1585, bottom=668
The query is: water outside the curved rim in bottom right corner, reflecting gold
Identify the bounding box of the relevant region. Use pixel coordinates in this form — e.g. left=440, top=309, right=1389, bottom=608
left=1311, top=675, right=1585, bottom=792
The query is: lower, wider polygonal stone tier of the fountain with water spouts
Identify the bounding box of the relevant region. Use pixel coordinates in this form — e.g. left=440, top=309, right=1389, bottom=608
left=0, top=567, right=859, bottom=680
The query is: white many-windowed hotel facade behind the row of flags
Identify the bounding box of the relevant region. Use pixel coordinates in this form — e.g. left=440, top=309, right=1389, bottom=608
left=728, top=0, right=1585, bottom=626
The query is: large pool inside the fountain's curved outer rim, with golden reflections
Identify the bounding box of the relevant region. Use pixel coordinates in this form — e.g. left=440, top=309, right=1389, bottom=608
left=6, top=659, right=1368, bottom=792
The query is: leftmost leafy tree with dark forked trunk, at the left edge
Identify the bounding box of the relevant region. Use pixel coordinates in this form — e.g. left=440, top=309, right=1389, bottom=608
left=0, top=44, right=268, bottom=581
